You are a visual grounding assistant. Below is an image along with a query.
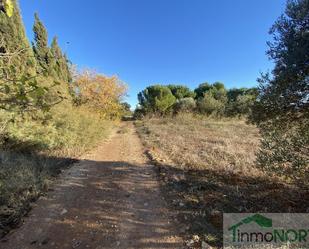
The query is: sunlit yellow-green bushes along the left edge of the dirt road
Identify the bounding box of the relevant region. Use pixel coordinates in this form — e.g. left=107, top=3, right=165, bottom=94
left=2, top=103, right=109, bottom=154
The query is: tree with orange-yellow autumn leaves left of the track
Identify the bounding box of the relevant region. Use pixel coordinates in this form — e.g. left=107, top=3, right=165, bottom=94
left=75, top=71, right=127, bottom=118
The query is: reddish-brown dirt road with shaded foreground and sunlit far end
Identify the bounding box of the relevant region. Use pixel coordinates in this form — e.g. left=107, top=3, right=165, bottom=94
left=0, top=123, right=183, bottom=249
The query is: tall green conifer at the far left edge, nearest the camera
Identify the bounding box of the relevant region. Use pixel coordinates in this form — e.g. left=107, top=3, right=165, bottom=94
left=0, top=2, right=61, bottom=115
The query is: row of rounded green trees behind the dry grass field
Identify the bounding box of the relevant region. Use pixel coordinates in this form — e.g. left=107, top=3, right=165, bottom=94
left=136, top=82, right=257, bottom=117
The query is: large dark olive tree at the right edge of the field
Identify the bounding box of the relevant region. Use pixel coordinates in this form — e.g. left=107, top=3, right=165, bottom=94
left=251, top=0, right=309, bottom=180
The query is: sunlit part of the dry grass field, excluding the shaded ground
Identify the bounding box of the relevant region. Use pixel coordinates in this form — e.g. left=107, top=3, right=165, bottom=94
left=140, top=114, right=261, bottom=175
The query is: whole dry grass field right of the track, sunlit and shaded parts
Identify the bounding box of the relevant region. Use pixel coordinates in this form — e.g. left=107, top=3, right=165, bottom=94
left=136, top=114, right=309, bottom=246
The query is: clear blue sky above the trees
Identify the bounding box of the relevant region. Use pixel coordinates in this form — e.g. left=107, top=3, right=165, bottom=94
left=20, top=0, right=285, bottom=107
